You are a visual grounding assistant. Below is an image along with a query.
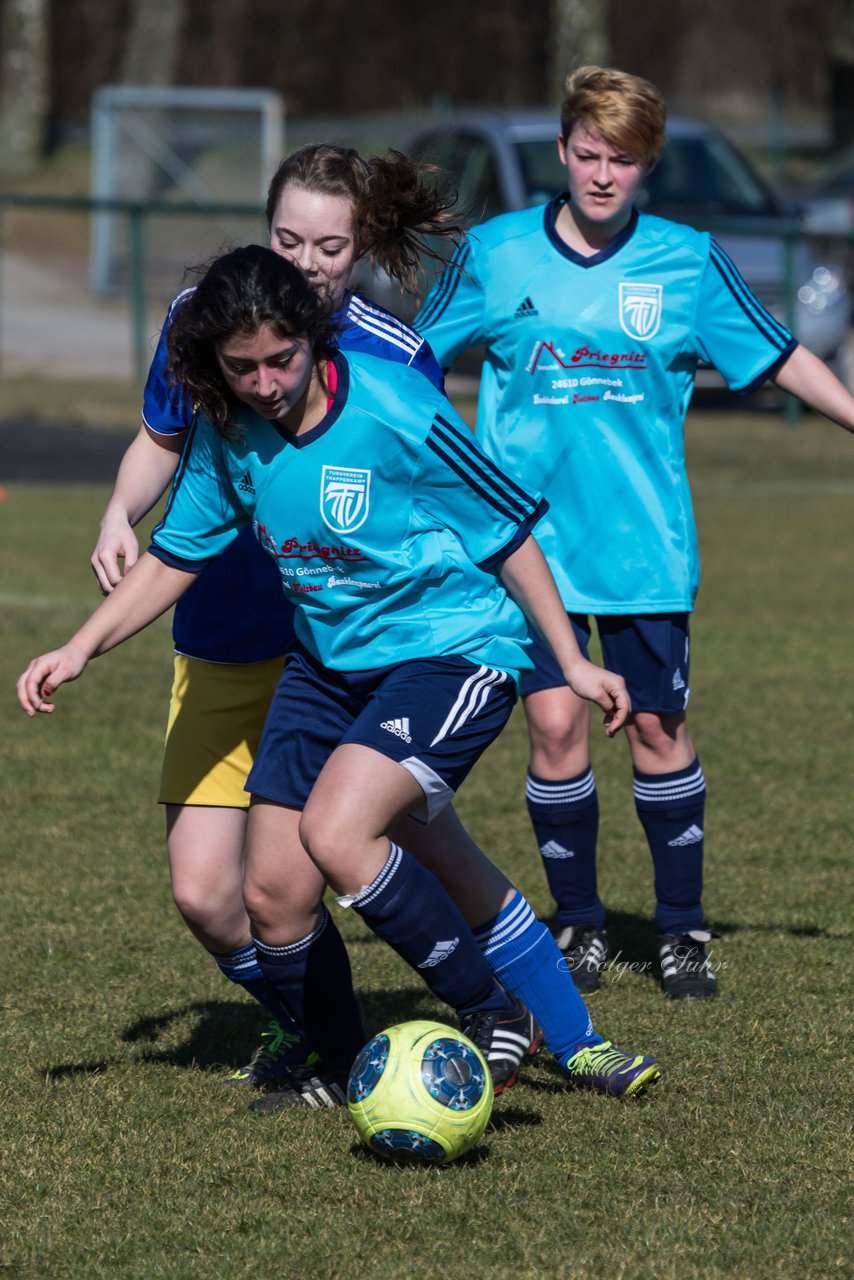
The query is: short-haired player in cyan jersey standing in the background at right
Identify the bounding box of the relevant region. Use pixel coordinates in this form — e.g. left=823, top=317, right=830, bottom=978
left=416, top=67, right=854, bottom=998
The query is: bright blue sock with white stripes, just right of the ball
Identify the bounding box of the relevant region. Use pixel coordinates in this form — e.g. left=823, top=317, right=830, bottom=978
left=474, top=892, right=602, bottom=1064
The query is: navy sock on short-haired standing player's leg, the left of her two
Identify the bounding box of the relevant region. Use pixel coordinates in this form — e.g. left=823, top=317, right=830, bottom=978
left=525, top=767, right=604, bottom=929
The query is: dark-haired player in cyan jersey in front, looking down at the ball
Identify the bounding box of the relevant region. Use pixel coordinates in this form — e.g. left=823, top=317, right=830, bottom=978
left=18, top=247, right=658, bottom=1111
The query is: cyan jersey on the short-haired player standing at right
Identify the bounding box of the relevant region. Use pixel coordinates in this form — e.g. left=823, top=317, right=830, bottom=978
left=416, top=197, right=796, bottom=614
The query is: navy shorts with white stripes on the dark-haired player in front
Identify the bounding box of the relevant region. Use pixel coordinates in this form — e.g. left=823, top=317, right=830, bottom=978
left=246, top=649, right=516, bottom=822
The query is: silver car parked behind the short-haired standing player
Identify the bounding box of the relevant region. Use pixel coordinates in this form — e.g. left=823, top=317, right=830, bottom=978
left=360, top=111, right=850, bottom=373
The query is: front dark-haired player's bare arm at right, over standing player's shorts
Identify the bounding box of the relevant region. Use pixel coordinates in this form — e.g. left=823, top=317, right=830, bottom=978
left=501, top=535, right=631, bottom=737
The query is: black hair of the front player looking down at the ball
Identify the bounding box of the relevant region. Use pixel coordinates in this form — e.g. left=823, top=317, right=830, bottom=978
left=166, top=244, right=334, bottom=435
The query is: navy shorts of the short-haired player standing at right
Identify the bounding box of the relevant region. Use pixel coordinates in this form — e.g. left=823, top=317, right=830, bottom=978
left=522, top=613, right=690, bottom=716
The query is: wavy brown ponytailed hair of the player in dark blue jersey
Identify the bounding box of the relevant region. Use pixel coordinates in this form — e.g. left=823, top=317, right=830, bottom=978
left=266, top=142, right=462, bottom=293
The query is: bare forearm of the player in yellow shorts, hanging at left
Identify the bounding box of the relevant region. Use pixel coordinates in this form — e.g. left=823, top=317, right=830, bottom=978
left=91, top=422, right=184, bottom=595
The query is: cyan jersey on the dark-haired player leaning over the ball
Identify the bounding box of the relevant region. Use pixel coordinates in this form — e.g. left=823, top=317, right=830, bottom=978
left=151, top=352, right=543, bottom=676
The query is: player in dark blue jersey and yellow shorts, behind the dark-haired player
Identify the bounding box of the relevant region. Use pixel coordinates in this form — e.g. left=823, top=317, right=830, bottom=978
left=92, top=145, right=471, bottom=1084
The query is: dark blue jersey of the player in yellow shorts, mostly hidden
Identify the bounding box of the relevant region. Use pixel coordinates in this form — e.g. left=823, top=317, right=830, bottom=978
left=142, top=291, right=443, bottom=663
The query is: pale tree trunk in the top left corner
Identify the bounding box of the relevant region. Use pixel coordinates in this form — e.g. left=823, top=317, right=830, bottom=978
left=0, top=0, right=49, bottom=175
